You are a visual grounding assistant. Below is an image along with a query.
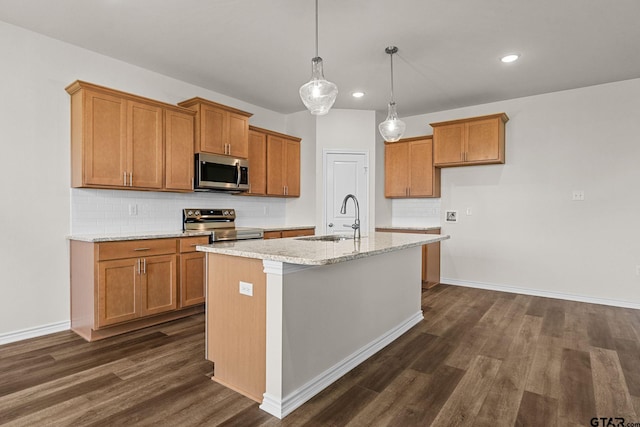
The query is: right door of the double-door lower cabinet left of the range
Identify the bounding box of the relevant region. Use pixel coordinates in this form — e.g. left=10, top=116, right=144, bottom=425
left=140, top=255, right=178, bottom=316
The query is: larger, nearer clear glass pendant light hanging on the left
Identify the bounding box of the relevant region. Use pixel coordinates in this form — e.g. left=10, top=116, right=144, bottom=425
left=300, top=0, right=338, bottom=116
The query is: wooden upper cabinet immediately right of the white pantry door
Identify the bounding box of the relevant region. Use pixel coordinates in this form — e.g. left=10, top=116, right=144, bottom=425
left=384, top=136, right=440, bottom=198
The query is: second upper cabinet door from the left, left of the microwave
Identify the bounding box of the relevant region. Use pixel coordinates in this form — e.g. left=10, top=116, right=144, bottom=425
left=127, top=101, right=164, bottom=188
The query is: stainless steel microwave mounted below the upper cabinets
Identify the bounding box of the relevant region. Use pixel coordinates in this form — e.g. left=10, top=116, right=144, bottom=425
left=193, top=153, right=249, bottom=192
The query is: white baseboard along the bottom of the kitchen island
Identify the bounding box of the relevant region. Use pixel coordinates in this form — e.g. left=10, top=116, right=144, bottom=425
left=260, top=310, right=424, bottom=419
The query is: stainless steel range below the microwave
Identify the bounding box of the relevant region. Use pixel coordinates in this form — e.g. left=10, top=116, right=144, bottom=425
left=182, top=209, right=264, bottom=242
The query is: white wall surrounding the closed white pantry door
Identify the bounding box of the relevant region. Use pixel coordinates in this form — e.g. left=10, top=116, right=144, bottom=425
left=315, top=109, right=376, bottom=233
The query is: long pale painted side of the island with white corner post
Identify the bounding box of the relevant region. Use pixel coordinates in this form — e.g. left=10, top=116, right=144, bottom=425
left=261, top=247, right=423, bottom=418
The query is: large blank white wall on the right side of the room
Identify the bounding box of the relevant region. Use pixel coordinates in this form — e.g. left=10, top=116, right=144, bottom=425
left=403, top=79, right=640, bottom=307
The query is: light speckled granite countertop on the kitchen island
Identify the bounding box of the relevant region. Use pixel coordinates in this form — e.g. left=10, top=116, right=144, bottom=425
left=196, top=233, right=450, bottom=265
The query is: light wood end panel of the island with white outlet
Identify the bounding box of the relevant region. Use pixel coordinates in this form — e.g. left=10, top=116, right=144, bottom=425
left=206, top=253, right=266, bottom=403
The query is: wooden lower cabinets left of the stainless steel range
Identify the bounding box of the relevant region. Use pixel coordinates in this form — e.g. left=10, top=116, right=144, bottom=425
left=70, top=237, right=208, bottom=341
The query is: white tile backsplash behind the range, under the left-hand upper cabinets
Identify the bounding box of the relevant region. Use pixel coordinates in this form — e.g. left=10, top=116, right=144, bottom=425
left=70, top=188, right=286, bottom=235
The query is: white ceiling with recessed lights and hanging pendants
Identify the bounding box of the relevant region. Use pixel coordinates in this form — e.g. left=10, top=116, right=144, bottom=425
left=0, top=0, right=640, bottom=116
